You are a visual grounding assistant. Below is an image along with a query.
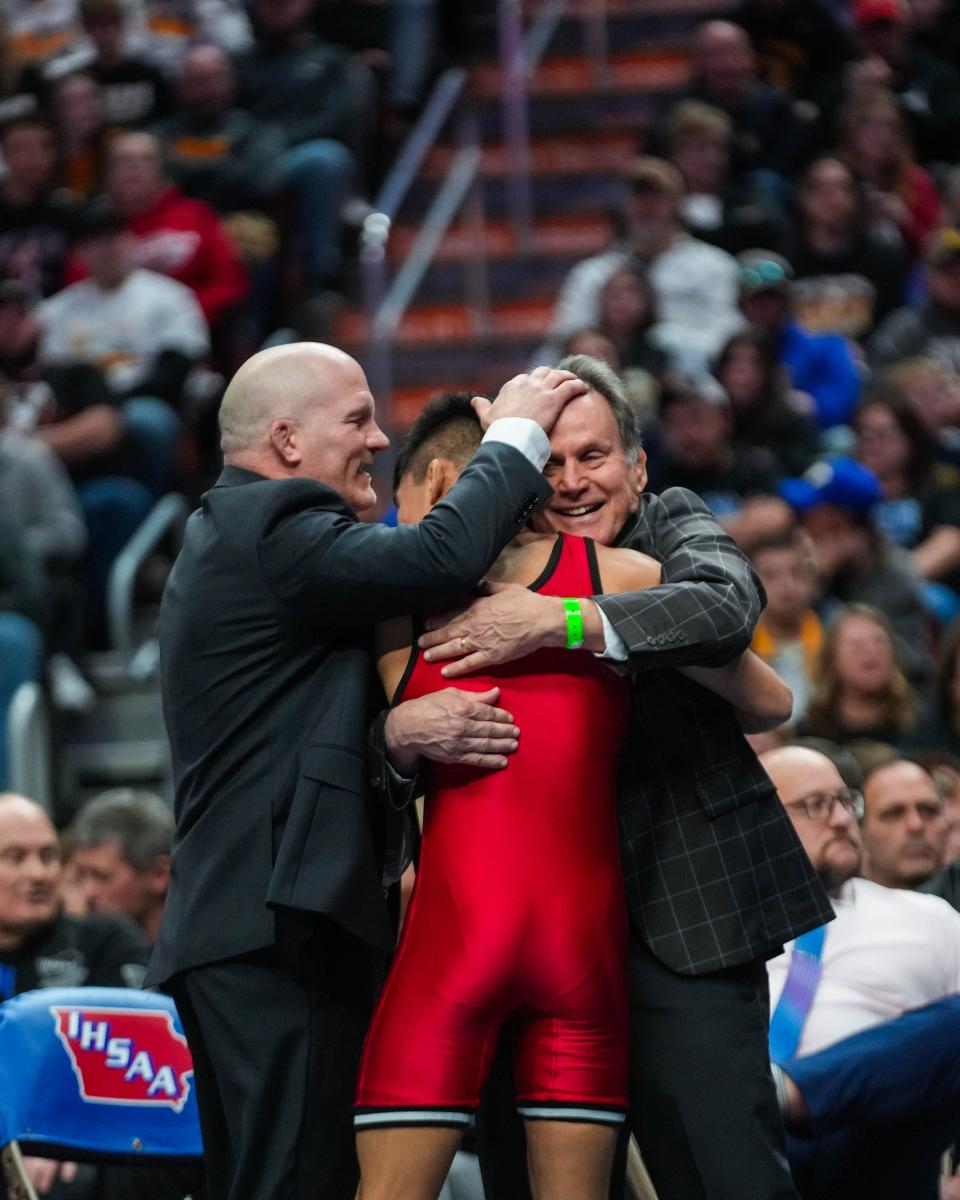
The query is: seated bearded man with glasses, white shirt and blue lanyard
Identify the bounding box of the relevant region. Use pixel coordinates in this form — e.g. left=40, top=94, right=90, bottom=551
left=761, top=746, right=960, bottom=1200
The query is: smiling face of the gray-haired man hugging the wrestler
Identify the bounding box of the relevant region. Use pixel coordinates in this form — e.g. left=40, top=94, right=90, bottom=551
left=534, top=391, right=647, bottom=546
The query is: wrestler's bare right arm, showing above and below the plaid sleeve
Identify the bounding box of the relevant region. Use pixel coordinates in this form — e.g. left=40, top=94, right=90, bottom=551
left=596, top=546, right=793, bottom=733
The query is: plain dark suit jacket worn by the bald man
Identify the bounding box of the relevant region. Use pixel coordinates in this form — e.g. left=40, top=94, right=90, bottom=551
left=148, top=444, right=550, bottom=983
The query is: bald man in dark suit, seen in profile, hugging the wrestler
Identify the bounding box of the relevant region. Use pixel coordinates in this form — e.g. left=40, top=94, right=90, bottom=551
left=149, top=343, right=584, bottom=1200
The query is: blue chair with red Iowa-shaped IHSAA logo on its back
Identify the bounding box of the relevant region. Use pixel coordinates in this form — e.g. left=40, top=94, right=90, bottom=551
left=0, top=988, right=203, bottom=1200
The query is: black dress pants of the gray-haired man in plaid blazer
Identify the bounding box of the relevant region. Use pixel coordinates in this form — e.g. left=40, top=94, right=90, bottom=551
left=478, top=937, right=798, bottom=1200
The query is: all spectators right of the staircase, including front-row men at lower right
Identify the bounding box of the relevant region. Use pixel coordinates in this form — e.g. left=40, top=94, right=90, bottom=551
left=541, top=7, right=960, bottom=1200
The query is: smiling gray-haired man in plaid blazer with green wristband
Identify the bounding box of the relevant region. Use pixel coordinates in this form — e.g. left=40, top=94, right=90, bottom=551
left=421, top=356, right=832, bottom=1200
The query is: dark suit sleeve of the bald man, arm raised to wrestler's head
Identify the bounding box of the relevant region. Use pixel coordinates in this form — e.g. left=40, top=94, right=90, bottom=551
left=258, top=443, right=550, bottom=629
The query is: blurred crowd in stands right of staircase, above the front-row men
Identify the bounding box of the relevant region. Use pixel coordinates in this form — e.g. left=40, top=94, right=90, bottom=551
left=538, top=0, right=960, bottom=796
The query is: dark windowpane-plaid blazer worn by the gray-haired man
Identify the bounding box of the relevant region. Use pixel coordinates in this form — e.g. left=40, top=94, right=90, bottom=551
left=596, top=488, right=833, bottom=976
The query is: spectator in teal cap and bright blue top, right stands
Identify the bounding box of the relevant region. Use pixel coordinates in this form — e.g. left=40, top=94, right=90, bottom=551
left=737, top=250, right=860, bottom=430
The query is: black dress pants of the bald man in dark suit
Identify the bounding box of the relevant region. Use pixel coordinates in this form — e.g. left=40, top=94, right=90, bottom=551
left=169, top=925, right=383, bottom=1200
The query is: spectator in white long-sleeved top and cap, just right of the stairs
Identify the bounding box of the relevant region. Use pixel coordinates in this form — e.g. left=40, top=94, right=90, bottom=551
left=540, top=157, right=744, bottom=371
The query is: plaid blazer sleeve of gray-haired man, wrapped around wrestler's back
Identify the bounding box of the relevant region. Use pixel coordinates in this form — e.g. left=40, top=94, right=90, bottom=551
left=594, top=487, right=766, bottom=671
